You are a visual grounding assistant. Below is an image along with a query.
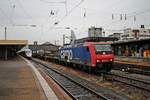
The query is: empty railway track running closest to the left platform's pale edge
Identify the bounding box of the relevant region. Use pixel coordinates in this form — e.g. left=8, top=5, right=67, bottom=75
left=31, top=61, right=109, bottom=100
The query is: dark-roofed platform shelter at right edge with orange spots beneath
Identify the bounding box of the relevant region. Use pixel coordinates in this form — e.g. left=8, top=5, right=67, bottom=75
left=112, top=39, right=150, bottom=58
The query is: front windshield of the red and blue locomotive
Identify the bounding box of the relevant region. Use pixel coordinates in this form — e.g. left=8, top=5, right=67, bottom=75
left=95, top=44, right=112, bottom=54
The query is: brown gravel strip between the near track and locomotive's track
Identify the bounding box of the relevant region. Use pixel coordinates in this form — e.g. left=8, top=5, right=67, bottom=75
left=33, top=60, right=150, bottom=100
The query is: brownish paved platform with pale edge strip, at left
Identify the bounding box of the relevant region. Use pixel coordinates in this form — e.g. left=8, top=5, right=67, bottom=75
left=0, top=56, right=58, bottom=100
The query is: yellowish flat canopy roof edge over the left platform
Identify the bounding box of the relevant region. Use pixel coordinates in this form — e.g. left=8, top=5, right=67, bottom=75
left=0, top=40, right=28, bottom=46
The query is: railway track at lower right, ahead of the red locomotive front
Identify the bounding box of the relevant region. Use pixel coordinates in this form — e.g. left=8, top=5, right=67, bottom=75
left=104, top=73, right=150, bottom=91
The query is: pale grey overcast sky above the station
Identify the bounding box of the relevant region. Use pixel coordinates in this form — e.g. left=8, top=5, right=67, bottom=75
left=0, top=0, right=150, bottom=44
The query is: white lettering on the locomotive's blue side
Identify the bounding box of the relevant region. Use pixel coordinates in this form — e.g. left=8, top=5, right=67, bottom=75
left=60, top=50, right=73, bottom=61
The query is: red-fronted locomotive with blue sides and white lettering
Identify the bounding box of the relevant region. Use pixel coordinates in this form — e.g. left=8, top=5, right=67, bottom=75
left=58, top=37, right=114, bottom=72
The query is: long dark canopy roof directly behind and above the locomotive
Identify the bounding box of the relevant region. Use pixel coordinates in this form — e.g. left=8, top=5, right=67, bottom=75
left=75, top=37, right=118, bottom=44
